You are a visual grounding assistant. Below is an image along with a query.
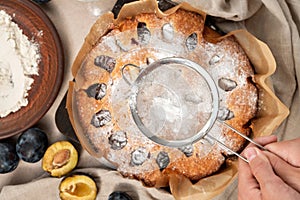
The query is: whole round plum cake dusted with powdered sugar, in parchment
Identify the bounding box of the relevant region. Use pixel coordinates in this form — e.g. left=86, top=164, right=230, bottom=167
left=72, top=9, right=257, bottom=186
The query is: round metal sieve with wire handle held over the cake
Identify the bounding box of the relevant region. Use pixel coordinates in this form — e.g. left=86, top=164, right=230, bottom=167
left=122, top=57, right=264, bottom=162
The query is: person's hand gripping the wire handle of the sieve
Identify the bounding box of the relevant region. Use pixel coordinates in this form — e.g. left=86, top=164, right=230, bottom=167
left=238, top=136, right=300, bottom=200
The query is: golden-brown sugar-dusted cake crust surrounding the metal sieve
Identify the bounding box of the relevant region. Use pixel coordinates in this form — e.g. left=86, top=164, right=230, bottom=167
left=72, top=9, right=257, bottom=187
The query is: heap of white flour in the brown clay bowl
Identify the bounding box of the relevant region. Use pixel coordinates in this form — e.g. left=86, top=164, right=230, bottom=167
left=0, top=10, right=40, bottom=117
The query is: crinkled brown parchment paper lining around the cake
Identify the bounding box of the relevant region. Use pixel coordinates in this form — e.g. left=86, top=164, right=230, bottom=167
left=67, top=0, right=289, bottom=199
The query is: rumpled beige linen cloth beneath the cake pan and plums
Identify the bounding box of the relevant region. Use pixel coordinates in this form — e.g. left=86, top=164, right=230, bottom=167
left=0, top=0, right=300, bottom=200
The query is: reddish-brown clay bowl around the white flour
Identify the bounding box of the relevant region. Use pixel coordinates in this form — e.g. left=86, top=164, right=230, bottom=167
left=0, top=0, right=64, bottom=139
